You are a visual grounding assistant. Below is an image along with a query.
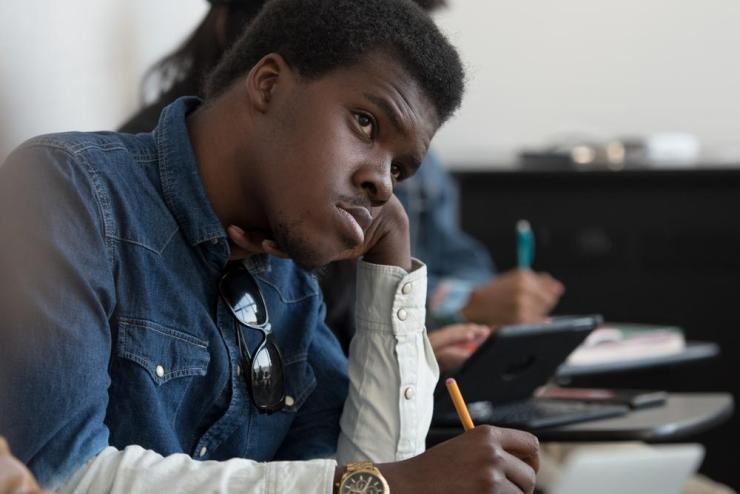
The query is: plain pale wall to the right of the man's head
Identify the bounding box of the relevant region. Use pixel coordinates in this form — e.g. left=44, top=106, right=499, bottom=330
left=435, top=0, right=740, bottom=165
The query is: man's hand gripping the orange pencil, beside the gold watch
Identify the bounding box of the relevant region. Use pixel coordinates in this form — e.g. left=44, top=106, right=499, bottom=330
left=378, top=425, right=539, bottom=494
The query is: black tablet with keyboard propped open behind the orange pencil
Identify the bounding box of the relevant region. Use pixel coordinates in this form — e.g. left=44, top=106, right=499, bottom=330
left=433, top=315, right=629, bottom=431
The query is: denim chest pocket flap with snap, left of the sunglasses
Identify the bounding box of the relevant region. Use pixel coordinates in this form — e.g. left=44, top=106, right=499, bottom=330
left=116, top=318, right=210, bottom=385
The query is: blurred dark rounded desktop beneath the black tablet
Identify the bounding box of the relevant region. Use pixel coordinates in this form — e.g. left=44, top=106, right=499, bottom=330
left=427, top=393, right=734, bottom=446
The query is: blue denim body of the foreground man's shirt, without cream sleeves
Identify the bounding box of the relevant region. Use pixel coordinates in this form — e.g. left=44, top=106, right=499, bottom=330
left=0, top=98, right=348, bottom=487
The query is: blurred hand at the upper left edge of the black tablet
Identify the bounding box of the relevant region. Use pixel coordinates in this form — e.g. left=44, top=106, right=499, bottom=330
left=428, top=324, right=491, bottom=373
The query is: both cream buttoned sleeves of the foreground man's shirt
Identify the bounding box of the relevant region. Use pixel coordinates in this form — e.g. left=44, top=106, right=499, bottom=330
left=59, top=261, right=439, bottom=494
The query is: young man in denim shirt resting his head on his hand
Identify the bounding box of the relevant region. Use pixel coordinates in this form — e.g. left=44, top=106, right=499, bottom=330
left=0, top=0, right=538, bottom=494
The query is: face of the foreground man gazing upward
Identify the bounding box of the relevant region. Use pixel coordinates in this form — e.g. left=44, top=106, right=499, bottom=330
left=253, top=55, right=439, bottom=267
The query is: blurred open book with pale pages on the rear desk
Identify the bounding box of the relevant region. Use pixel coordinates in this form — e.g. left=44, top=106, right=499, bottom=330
left=566, top=323, right=686, bottom=366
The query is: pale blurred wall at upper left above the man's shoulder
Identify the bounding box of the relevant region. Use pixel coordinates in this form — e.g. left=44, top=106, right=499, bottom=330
left=0, top=0, right=207, bottom=159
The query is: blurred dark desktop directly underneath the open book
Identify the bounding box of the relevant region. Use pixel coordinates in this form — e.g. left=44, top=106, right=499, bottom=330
left=556, top=341, right=719, bottom=382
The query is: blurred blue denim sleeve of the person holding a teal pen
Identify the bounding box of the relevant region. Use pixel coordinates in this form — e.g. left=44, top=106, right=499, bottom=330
left=394, top=151, right=494, bottom=327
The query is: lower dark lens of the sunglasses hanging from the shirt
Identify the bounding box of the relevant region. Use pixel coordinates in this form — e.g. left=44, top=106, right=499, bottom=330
left=251, top=335, right=285, bottom=409
